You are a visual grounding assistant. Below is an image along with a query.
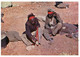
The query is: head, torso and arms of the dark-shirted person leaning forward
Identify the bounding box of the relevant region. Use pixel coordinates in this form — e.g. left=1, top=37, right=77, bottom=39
left=23, top=13, right=40, bottom=45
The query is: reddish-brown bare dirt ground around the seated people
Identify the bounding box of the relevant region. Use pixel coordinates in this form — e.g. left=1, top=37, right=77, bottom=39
left=1, top=2, right=78, bottom=55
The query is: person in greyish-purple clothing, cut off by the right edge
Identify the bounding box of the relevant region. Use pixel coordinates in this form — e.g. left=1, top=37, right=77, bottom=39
left=59, top=23, right=78, bottom=38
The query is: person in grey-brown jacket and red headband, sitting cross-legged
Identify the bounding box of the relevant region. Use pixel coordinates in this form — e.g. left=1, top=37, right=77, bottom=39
left=43, top=9, right=63, bottom=44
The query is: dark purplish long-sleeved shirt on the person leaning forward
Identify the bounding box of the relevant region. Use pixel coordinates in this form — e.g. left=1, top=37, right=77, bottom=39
left=25, top=19, right=40, bottom=41
